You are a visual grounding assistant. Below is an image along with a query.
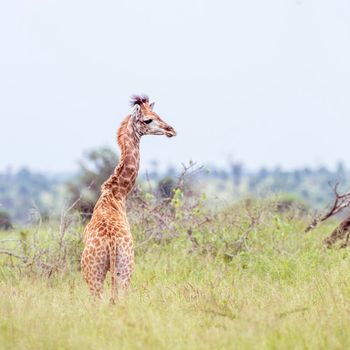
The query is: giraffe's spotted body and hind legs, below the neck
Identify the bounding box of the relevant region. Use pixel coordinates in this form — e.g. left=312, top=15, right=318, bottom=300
left=82, top=193, right=134, bottom=300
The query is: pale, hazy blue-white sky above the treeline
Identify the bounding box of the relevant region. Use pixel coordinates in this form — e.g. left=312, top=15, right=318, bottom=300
left=0, top=0, right=350, bottom=172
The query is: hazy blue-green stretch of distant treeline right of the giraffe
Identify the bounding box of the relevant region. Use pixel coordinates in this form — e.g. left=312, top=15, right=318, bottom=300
left=201, top=163, right=350, bottom=208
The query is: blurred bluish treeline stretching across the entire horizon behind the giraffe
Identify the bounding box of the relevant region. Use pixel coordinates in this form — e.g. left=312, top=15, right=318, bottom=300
left=0, top=148, right=350, bottom=224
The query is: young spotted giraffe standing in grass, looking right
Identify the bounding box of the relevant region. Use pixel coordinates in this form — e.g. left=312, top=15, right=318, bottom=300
left=81, top=95, right=176, bottom=302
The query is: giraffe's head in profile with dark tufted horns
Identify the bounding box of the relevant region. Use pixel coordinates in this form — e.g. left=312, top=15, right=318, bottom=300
left=130, top=95, right=176, bottom=137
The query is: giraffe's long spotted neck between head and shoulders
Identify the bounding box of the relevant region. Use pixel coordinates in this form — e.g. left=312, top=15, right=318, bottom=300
left=102, top=118, right=140, bottom=199
